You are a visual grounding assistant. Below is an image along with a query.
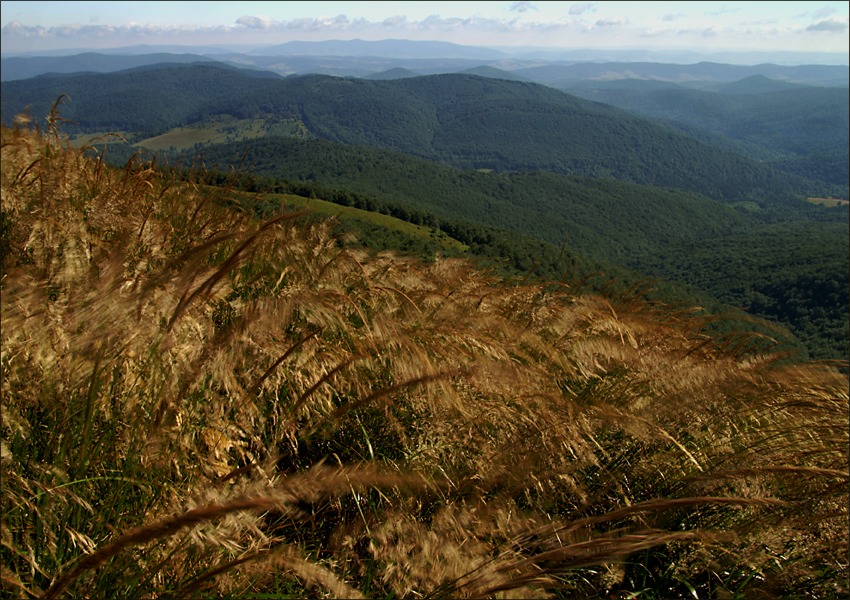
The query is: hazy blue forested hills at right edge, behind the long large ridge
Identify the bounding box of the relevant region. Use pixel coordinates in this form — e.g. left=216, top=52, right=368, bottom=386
left=565, top=76, right=850, bottom=186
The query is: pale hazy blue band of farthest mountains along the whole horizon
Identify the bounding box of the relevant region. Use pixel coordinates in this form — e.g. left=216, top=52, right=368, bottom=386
left=2, top=40, right=848, bottom=82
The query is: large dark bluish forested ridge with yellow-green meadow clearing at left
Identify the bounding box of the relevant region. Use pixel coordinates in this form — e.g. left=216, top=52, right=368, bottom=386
left=2, top=64, right=824, bottom=203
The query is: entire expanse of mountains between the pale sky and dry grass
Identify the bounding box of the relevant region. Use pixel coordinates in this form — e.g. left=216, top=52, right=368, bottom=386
left=0, top=48, right=848, bottom=357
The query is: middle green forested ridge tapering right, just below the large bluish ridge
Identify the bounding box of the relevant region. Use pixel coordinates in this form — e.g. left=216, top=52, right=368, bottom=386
left=184, top=138, right=748, bottom=262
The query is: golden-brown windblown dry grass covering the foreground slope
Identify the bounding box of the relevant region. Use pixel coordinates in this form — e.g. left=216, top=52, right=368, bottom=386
left=0, top=115, right=850, bottom=598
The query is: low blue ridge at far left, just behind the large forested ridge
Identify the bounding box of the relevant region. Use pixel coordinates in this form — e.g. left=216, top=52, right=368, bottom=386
left=0, top=52, right=219, bottom=81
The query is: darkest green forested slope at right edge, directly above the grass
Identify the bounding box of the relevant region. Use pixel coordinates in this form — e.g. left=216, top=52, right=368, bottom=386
left=629, top=220, right=850, bottom=359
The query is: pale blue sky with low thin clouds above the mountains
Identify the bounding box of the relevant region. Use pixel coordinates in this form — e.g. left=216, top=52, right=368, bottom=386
left=0, top=0, right=850, bottom=58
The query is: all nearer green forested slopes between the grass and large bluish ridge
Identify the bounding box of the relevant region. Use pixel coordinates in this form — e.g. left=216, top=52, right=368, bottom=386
left=181, top=137, right=850, bottom=358
